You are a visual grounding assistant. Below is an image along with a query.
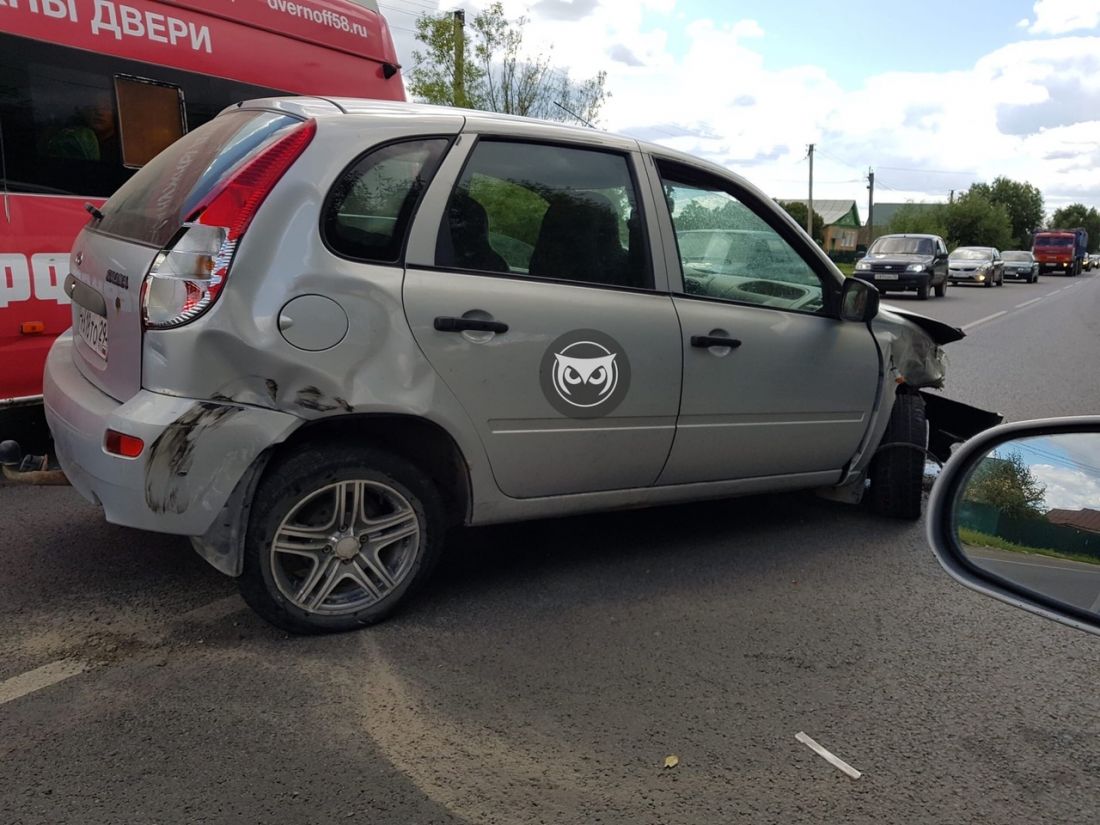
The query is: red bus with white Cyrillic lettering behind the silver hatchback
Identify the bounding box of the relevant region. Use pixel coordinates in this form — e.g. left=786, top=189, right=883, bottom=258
left=0, top=0, right=405, bottom=409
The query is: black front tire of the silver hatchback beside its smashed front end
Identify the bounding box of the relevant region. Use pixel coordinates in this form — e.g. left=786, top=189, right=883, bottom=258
left=867, top=393, right=928, bottom=520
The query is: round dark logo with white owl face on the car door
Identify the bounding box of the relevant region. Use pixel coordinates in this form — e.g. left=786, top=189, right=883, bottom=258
left=540, top=330, right=630, bottom=418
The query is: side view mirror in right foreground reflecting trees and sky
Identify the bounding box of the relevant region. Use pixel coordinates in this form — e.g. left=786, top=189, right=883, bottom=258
left=927, top=416, right=1100, bottom=635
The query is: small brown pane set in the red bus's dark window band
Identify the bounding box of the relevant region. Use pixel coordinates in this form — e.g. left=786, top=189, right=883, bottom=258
left=114, top=75, right=187, bottom=169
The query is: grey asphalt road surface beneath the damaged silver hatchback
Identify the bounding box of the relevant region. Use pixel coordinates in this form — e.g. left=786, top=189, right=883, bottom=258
left=0, top=268, right=1100, bottom=825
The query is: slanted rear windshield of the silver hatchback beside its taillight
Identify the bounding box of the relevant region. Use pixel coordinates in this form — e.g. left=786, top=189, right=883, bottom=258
left=97, top=111, right=299, bottom=246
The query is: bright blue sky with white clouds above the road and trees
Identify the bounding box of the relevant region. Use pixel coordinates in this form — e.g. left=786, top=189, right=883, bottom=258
left=380, top=0, right=1100, bottom=217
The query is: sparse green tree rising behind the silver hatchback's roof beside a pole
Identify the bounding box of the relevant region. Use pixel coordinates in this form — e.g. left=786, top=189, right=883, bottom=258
left=408, top=2, right=608, bottom=123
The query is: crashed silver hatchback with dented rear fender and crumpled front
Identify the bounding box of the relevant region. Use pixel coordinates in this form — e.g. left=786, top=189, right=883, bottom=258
left=45, top=98, right=997, bottom=631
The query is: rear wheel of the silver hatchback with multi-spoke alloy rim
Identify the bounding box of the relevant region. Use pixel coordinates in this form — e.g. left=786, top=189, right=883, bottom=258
left=239, top=446, right=444, bottom=634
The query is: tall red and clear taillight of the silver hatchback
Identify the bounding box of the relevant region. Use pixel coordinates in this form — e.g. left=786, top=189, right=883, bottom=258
left=142, top=120, right=317, bottom=329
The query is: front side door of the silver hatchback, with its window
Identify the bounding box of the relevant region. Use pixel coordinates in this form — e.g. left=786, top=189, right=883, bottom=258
left=660, top=164, right=879, bottom=484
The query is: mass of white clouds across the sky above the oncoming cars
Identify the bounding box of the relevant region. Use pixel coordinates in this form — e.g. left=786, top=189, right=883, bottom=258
left=395, top=0, right=1100, bottom=210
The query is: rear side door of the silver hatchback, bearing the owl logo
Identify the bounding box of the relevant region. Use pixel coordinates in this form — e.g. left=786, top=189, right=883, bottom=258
left=404, top=138, right=681, bottom=497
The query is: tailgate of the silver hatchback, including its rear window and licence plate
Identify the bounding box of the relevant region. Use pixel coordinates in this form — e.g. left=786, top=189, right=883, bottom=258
left=65, top=110, right=300, bottom=400
